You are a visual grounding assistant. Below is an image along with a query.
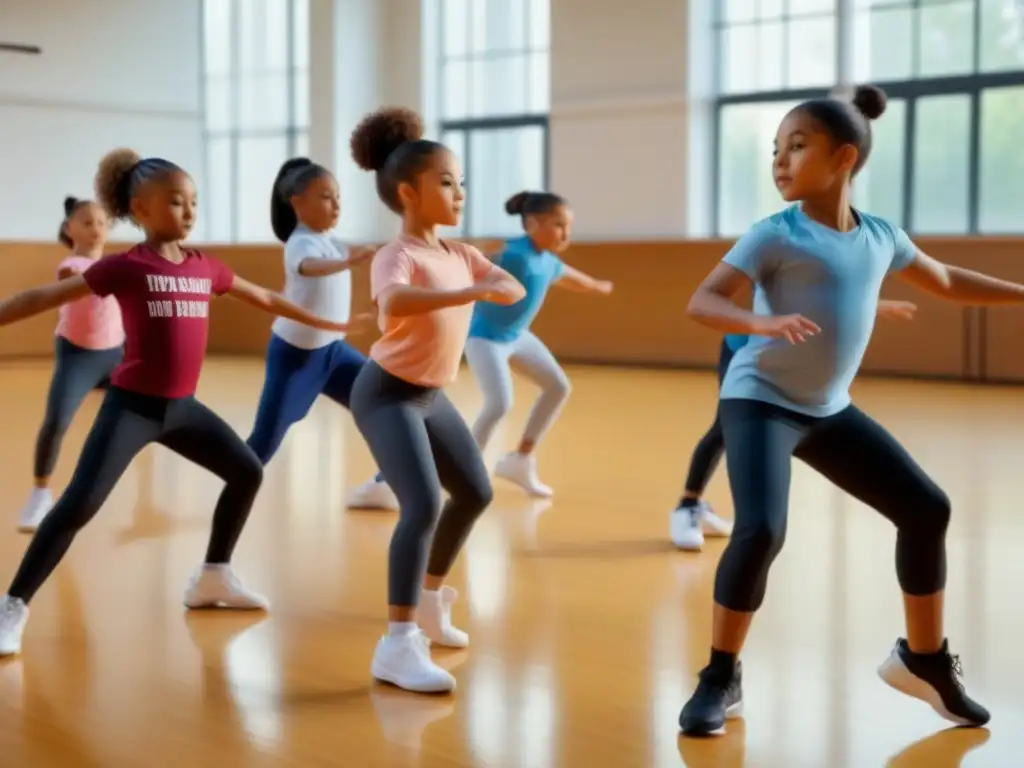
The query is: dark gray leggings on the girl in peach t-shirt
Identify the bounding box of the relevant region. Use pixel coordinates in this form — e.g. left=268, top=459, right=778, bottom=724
left=349, top=360, right=494, bottom=606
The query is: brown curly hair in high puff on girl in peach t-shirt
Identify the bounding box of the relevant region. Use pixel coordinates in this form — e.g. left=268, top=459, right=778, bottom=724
left=351, top=106, right=446, bottom=214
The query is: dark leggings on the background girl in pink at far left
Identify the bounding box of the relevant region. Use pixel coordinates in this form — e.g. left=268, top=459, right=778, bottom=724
left=33, top=336, right=124, bottom=477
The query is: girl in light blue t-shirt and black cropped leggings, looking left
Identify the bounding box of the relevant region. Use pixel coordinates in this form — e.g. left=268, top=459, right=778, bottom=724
left=679, top=86, right=1024, bottom=735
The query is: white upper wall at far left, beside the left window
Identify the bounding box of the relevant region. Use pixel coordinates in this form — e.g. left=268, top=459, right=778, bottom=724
left=0, top=0, right=204, bottom=241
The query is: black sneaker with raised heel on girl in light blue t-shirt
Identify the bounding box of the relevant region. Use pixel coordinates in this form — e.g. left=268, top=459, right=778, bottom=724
left=879, top=638, right=991, bottom=727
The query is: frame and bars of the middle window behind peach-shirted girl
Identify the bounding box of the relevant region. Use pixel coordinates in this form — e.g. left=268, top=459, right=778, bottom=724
left=434, top=0, right=551, bottom=239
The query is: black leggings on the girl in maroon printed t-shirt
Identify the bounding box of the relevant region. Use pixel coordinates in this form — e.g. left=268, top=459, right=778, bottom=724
left=8, top=387, right=263, bottom=602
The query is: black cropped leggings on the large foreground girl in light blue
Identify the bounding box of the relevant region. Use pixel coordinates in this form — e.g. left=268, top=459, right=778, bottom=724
left=715, top=399, right=949, bottom=611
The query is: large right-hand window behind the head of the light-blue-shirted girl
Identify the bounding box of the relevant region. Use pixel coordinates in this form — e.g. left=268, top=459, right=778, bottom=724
left=714, top=0, right=1024, bottom=237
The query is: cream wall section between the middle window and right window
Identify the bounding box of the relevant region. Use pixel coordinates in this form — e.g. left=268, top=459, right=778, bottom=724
left=551, top=0, right=709, bottom=240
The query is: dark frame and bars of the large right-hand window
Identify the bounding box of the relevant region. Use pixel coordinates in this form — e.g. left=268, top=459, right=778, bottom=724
left=710, top=0, right=1024, bottom=237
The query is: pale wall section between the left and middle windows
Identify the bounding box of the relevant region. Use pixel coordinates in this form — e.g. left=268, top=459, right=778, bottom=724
left=309, top=0, right=423, bottom=241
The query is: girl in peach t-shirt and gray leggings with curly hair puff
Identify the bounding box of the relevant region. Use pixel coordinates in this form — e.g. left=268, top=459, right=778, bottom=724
left=350, top=109, right=525, bottom=693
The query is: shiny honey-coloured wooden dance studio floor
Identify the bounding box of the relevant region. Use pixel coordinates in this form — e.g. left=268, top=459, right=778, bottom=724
left=0, top=359, right=1024, bottom=768
